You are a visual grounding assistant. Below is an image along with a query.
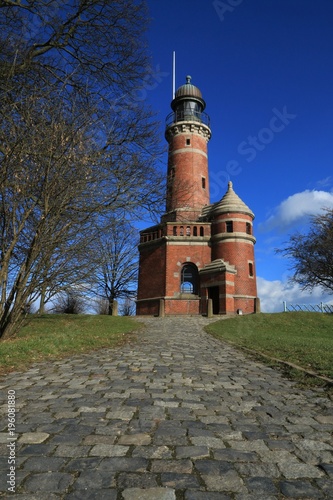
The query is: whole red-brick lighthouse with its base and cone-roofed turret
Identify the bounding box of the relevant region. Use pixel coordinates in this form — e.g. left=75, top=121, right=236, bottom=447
left=137, top=76, right=259, bottom=316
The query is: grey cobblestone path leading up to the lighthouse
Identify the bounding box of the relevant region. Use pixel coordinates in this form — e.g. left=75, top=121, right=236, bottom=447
left=0, top=318, right=333, bottom=500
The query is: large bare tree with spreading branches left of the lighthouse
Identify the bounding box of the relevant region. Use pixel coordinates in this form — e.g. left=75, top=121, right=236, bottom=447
left=0, top=0, right=165, bottom=337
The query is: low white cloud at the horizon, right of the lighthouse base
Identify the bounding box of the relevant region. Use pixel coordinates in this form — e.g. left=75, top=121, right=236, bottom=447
left=257, top=277, right=333, bottom=312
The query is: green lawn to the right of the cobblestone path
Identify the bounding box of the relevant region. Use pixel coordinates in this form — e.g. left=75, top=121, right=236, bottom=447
left=206, top=312, right=333, bottom=386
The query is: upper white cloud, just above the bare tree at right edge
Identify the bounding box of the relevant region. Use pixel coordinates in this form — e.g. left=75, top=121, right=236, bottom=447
left=259, top=189, right=333, bottom=232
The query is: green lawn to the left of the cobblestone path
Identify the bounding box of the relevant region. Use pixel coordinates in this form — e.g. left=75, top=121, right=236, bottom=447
left=0, top=314, right=141, bottom=375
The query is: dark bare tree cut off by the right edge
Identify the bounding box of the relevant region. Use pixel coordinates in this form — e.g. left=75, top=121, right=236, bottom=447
left=277, top=209, right=333, bottom=293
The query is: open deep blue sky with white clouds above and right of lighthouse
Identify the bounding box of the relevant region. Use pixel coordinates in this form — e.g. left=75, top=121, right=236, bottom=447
left=142, top=0, right=333, bottom=312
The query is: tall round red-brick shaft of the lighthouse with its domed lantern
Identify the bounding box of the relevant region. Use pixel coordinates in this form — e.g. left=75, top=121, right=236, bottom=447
left=164, top=76, right=211, bottom=221
